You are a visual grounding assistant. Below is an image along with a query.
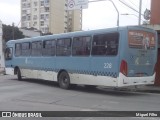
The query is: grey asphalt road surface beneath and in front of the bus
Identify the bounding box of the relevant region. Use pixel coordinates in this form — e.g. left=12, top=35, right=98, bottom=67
left=0, top=75, right=160, bottom=120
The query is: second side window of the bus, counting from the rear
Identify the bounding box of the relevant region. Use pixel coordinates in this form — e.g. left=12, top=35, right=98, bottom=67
left=72, top=37, right=91, bottom=56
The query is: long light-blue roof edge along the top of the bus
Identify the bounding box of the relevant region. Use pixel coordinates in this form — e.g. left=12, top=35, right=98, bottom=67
left=7, top=26, right=154, bottom=44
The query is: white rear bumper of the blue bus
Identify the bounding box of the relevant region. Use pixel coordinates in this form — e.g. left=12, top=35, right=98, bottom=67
left=117, top=73, right=156, bottom=87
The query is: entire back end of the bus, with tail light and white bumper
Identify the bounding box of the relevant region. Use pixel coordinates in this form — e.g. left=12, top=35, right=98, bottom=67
left=118, top=27, right=157, bottom=87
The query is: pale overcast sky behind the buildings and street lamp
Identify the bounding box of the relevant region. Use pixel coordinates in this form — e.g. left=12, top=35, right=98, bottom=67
left=0, top=0, right=150, bottom=30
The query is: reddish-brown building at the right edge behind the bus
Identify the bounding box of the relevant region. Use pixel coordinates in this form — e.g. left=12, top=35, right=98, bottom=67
left=145, top=0, right=160, bottom=86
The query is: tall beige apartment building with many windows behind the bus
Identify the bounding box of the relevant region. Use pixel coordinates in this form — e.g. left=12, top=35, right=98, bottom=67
left=21, top=0, right=82, bottom=34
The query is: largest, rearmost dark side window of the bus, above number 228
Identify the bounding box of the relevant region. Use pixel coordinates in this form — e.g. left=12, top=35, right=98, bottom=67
left=92, top=33, right=119, bottom=56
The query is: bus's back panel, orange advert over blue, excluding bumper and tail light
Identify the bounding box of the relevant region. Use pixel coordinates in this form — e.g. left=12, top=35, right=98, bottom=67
left=126, top=30, right=156, bottom=77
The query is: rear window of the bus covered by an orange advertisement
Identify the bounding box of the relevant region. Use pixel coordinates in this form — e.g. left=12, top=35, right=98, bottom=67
left=128, top=30, right=156, bottom=50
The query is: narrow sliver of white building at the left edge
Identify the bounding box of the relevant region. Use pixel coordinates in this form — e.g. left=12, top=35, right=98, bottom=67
left=0, top=20, right=5, bottom=74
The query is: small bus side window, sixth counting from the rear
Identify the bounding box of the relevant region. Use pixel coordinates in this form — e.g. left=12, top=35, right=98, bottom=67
left=22, top=43, right=30, bottom=56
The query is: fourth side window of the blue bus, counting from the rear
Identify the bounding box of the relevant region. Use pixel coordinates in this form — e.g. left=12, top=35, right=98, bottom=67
left=43, top=40, right=56, bottom=56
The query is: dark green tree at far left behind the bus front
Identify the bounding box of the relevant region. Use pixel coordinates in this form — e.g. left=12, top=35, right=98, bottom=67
left=2, top=24, right=25, bottom=42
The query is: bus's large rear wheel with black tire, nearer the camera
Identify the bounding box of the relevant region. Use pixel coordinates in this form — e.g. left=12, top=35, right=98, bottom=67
left=58, top=71, right=70, bottom=89
